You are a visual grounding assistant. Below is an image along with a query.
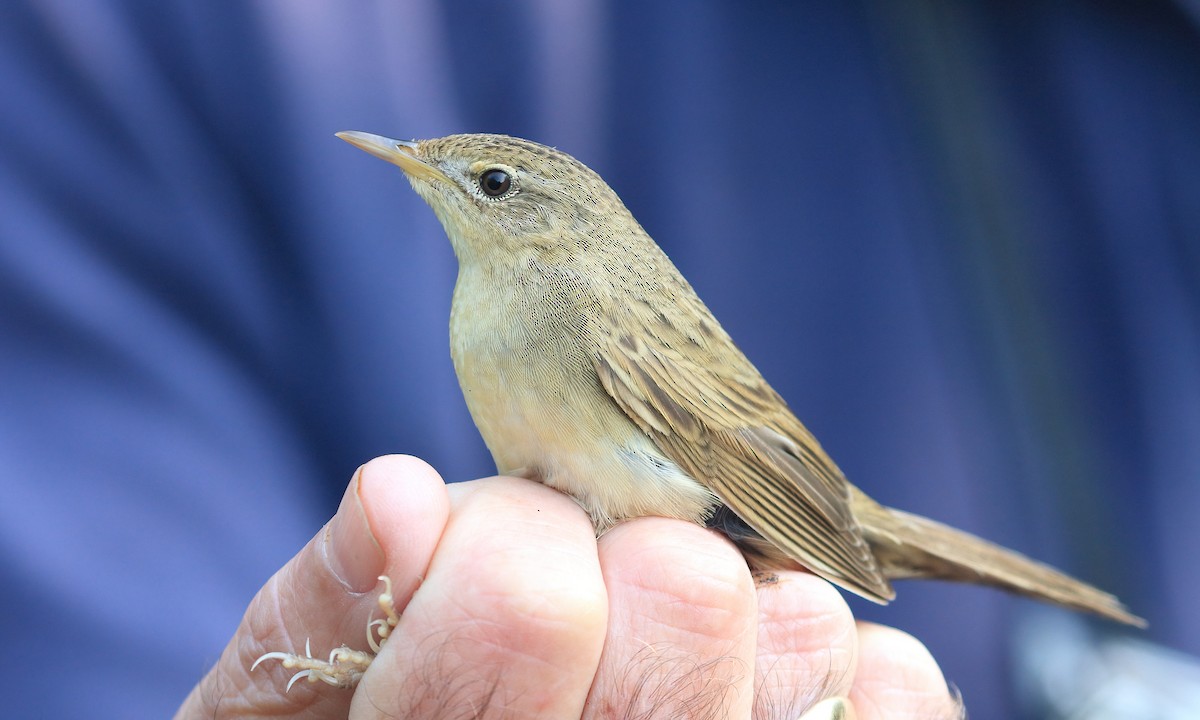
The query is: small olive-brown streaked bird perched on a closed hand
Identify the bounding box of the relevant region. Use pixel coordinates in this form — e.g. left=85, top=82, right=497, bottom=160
left=337, top=131, right=1145, bottom=626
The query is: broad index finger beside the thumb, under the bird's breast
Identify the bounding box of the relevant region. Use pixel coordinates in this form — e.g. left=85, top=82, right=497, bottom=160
left=350, top=478, right=607, bottom=720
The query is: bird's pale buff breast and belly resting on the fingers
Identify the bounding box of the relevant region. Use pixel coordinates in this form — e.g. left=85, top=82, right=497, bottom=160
left=451, top=285, right=716, bottom=532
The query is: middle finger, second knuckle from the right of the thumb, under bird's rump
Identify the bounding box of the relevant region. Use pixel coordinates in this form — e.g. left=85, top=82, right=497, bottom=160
left=584, top=517, right=757, bottom=719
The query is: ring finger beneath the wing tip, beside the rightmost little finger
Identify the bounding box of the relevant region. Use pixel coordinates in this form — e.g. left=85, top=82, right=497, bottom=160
left=754, top=570, right=858, bottom=720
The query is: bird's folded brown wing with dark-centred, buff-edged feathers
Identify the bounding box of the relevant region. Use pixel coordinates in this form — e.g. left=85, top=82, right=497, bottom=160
left=593, top=318, right=894, bottom=602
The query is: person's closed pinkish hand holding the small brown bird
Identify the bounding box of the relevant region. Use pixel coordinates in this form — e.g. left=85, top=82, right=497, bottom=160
left=176, top=456, right=959, bottom=720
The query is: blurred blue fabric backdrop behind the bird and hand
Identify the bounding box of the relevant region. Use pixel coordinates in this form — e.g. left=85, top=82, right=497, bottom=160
left=0, top=0, right=1200, bottom=718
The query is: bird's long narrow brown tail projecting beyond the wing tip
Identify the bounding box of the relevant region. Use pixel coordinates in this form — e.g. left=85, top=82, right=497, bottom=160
left=860, top=503, right=1146, bottom=628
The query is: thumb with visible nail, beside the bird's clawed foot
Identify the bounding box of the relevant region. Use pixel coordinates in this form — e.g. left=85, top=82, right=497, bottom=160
left=176, top=456, right=449, bottom=718
